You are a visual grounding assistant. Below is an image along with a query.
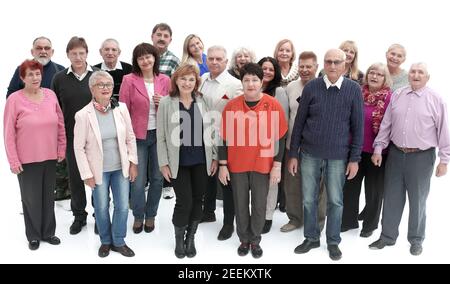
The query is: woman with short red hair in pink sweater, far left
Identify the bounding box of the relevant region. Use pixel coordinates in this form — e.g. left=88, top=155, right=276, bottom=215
left=3, top=60, right=66, bottom=250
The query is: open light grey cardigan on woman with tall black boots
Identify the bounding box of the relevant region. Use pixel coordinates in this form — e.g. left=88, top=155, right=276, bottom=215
left=156, top=96, right=217, bottom=179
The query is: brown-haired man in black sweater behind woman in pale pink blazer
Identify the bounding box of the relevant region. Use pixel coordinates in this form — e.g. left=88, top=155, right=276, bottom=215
left=52, top=36, right=98, bottom=235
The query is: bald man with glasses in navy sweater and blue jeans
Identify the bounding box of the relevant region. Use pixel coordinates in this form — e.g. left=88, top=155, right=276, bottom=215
left=288, top=49, right=363, bottom=260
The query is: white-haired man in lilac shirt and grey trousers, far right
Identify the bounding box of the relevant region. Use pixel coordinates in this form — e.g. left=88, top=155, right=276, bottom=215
left=369, top=63, right=450, bottom=255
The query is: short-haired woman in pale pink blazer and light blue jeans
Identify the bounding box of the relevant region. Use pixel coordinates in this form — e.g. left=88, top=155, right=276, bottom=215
left=74, top=71, right=138, bottom=257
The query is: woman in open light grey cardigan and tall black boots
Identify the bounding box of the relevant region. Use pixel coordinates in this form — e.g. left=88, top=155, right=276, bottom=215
left=157, top=64, right=217, bottom=258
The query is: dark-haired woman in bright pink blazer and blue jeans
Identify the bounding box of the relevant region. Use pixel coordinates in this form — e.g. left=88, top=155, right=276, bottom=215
left=119, top=43, right=170, bottom=234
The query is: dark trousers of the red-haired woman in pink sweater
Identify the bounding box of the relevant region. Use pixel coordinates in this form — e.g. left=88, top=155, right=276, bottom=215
left=17, top=160, right=56, bottom=241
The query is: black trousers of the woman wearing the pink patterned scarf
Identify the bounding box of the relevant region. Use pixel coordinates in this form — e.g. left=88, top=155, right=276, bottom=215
left=342, top=152, right=387, bottom=232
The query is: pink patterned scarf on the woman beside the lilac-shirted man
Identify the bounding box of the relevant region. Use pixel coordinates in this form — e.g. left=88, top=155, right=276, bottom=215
left=362, top=85, right=391, bottom=134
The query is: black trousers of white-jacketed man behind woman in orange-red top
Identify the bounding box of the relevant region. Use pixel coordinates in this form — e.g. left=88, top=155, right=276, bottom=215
left=203, top=173, right=235, bottom=225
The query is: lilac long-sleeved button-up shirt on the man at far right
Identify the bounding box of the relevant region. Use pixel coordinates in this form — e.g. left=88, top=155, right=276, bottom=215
left=373, top=86, right=450, bottom=164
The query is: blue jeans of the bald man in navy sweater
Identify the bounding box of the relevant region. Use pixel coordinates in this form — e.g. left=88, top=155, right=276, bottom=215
left=300, top=152, right=347, bottom=245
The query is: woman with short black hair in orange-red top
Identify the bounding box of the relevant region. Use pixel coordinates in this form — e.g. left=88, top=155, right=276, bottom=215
left=219, top=63, right=288, bottom=258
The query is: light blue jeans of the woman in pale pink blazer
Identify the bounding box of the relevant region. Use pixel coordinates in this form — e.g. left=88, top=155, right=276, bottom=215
left=92, top=169, right=130, bottom=247
